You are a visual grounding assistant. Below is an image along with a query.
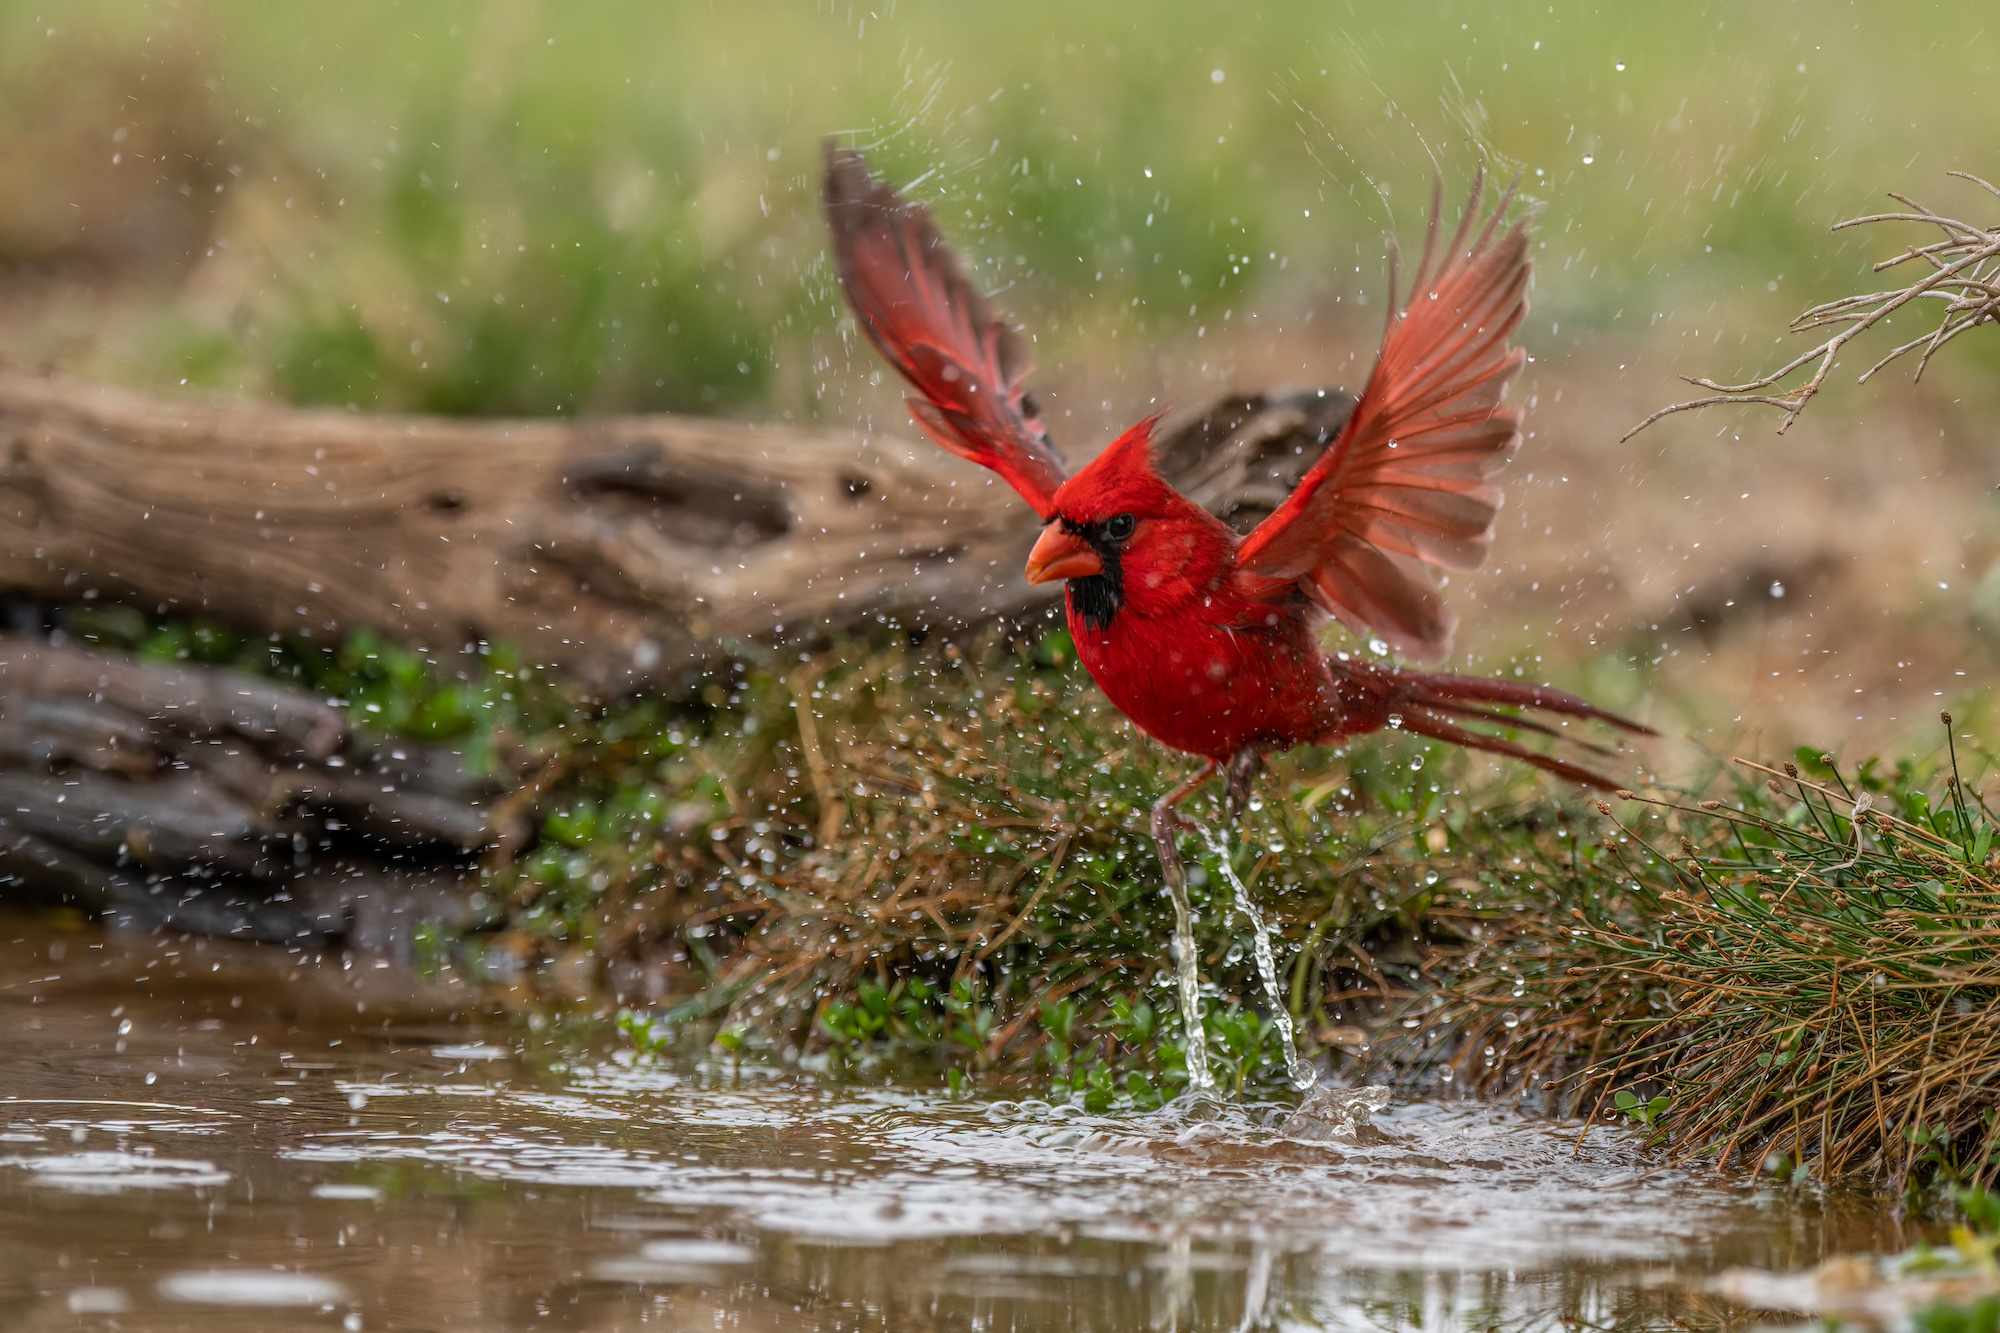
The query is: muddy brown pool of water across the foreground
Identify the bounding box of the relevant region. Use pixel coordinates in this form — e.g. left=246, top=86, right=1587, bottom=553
left=0, top=917, right=1912, bottom=1333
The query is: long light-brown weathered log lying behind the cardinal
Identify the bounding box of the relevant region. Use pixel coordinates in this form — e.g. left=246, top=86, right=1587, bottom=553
left=0, top=374, right=1350, bottom=688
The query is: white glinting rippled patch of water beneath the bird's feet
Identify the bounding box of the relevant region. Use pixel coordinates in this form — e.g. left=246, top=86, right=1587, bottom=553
left=290, top=1061, right=1740, bottom=1271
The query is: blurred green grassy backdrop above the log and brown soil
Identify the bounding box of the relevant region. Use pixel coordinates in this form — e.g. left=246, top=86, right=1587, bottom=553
left=0, top=0, right=2000, bottom=418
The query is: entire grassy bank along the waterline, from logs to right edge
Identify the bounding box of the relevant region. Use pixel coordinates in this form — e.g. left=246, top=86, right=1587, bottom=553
left=64, top=592, right=2000, bottom=1187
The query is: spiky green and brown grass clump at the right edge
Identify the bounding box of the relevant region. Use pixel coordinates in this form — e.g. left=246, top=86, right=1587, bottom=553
left=1418, top=717, right=2000, bottom=1185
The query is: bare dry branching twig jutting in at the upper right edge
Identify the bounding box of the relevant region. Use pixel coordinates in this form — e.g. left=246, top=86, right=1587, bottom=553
left=1624, top=172, right=2000, bottom=440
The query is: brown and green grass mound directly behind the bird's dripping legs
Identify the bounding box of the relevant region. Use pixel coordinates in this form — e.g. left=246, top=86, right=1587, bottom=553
left=508, top=636, right=1608, bottom=1073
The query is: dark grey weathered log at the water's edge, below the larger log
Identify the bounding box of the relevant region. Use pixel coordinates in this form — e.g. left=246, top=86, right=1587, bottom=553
left=0, top=636, right=508, bottom=949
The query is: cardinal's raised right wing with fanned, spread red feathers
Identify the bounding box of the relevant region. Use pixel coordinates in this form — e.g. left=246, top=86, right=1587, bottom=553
left=1238, top=172, right=1530, bottom=660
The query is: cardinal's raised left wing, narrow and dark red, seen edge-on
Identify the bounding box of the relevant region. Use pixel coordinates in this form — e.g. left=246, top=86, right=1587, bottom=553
left=824, top=142, right=1064, bottom=518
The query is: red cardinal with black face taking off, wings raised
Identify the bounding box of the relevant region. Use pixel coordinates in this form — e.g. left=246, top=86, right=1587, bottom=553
left=824, top=144, right=1650, bottom=892
